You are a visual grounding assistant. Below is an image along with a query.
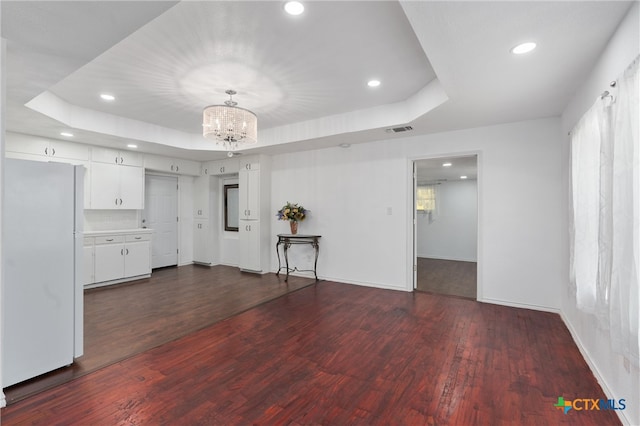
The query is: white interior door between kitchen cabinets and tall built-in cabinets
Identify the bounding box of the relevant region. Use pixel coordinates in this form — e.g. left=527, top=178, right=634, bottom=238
left=142, top=175, right=178, bottom=269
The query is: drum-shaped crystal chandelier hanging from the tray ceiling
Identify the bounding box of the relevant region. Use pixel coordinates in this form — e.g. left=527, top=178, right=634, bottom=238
left=202, top=90, right=258, bottom=151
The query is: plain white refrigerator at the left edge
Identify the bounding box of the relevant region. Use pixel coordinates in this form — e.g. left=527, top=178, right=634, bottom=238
left=1, top=159, right=84, bottom=387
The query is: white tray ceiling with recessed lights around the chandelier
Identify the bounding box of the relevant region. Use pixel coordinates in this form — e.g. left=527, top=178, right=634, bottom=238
left=0, top=0, right=632, bottom=160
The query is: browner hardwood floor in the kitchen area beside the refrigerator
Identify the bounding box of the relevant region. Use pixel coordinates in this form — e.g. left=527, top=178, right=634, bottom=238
left=5, top=265, right=314, bottom=404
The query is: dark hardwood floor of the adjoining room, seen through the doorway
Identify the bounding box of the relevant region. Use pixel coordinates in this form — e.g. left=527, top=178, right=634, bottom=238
left=416, top=257, right=478, bottom=300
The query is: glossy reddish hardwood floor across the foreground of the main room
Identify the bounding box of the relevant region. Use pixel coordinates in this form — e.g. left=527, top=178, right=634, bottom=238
left=2, top=282, right=620, bottom=426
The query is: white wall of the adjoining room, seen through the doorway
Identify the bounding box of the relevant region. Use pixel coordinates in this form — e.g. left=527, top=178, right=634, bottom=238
left=416, top=180, right=478, bottom=262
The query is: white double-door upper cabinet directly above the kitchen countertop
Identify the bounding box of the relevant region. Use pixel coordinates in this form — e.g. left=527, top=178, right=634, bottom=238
left=90, top=163, right=144, bottom=210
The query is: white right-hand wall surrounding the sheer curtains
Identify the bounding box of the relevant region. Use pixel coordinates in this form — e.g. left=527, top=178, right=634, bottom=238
left=557, top=2, right=640, bottom=425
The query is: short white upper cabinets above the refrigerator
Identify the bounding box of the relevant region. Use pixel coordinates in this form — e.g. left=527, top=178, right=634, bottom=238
left=5, top=132, right=89, bottom=164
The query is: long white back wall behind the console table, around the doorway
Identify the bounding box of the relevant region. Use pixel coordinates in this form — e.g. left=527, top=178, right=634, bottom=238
left=271, top=118, right=567, bottom=310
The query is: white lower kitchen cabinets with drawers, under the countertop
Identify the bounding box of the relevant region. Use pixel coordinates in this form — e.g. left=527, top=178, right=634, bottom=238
left=84, top=230, right=151, bottom=287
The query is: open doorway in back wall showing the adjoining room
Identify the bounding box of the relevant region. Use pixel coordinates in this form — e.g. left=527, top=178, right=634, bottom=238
left=414, top=155, right=478, bottom=300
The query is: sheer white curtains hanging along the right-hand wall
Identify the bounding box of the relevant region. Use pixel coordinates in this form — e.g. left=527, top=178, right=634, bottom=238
left=571, top=55, right=640, bottom=365
